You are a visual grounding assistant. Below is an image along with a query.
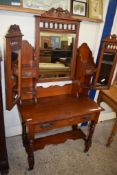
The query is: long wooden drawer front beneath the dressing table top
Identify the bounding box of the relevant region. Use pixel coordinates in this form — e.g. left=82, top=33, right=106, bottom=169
left=34, top=114, right=97, bottom=133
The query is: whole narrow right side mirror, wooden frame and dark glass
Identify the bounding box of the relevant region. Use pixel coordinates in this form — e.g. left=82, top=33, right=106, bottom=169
left=94, top=35, right=117, bottom=89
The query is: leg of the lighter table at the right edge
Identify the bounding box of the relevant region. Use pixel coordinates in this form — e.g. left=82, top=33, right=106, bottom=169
left=106, top=116, right=117, bottom=146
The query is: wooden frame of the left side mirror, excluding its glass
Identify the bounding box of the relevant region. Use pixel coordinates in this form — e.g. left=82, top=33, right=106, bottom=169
left=5, top=25, right=23, bottom=110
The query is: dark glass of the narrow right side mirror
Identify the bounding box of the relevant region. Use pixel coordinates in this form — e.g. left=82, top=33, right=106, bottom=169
left=97, top=52, right=115, bottom=87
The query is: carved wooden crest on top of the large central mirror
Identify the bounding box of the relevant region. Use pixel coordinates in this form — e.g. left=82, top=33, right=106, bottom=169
left=42, top=7, right=72, bottom=18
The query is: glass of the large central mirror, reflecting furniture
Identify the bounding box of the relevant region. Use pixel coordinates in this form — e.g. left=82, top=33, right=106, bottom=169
left=39, top=32, right=75, bottom=79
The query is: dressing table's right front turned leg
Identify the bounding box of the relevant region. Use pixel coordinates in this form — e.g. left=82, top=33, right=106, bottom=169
left=84, top=121, right=97, bottom=152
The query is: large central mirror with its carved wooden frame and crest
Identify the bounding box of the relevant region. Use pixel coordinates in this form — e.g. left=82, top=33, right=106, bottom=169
left=35, top=8, right=80, bottom=81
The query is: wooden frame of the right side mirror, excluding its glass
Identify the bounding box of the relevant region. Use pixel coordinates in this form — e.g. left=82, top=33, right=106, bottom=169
left=94, top=35, right=117, bottom=89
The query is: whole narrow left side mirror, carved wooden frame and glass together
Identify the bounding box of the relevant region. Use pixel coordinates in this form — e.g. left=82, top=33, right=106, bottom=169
left=5, top=25, right=22, bottom=110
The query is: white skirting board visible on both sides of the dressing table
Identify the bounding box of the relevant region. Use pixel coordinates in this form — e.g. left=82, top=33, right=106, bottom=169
left=5, top=112, right=116, bottom=137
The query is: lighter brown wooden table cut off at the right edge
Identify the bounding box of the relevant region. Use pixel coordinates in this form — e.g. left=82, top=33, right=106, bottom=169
left=98, top=86, right=117, bottom=146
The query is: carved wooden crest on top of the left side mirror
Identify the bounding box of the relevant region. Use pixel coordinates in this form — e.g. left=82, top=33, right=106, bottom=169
left=6, top=24, right=22, bottom=37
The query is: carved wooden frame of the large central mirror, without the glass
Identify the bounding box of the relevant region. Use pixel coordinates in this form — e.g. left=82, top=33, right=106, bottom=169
left=35, top=8, right=80, bottom=82
